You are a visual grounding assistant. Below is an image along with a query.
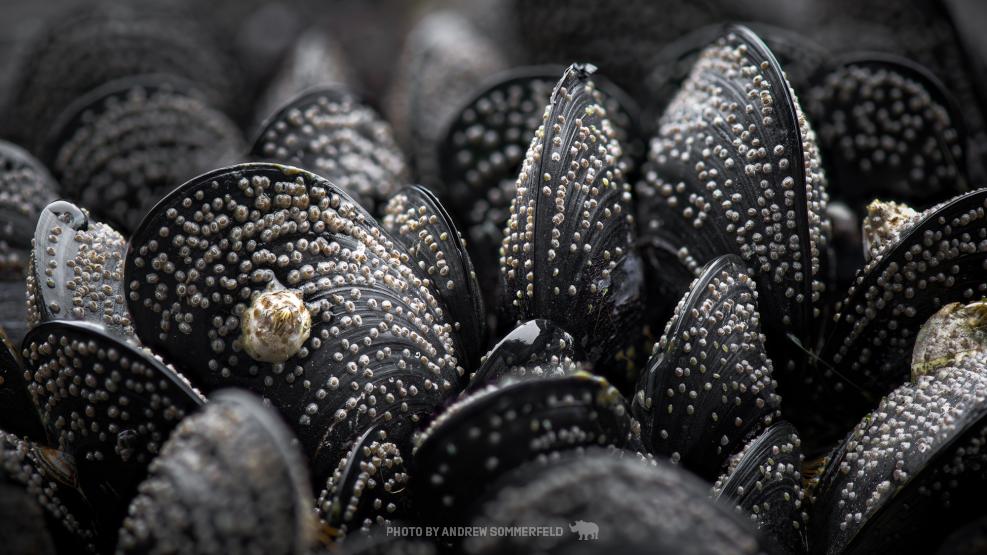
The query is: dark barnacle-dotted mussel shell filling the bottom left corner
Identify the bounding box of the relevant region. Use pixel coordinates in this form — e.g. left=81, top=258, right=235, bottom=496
left=0, top=432, right=97, bottom=554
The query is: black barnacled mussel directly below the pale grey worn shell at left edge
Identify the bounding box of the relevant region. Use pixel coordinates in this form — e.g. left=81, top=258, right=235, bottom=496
left=22, top=321, right=204, bottom=537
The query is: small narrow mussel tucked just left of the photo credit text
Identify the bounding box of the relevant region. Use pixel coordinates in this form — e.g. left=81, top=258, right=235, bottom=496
left=316, top=420, right=416, bottom=542
